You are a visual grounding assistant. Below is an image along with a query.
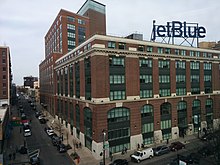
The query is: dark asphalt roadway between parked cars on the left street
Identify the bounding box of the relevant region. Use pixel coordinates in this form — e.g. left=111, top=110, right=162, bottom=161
left=22, top=97, right=74, bottom=165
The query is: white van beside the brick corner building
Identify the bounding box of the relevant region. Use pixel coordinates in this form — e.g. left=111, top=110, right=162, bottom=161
left=131, top=148, right=154, bottom=163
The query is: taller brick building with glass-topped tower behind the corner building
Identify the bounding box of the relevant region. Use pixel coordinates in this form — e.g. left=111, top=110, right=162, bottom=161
left=39, top=0, right=106, bottom=112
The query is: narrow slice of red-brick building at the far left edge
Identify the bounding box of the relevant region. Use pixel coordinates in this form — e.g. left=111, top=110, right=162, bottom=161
left=0, top=46, right=12, bottom=106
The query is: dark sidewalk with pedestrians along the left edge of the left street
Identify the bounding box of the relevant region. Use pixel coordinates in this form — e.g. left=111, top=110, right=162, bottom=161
left=3, top=106, right=29, bottom=165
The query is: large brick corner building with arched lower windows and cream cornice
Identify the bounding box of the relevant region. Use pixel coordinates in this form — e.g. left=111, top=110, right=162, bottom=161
left=54, top=35, right=220, bottom=158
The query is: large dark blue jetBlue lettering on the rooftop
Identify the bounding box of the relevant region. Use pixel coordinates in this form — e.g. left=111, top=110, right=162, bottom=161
left=151, top=21, right=206, bottom=41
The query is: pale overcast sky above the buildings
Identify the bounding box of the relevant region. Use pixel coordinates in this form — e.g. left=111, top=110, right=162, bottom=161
left=0, top=0, right=220, bottom=85
